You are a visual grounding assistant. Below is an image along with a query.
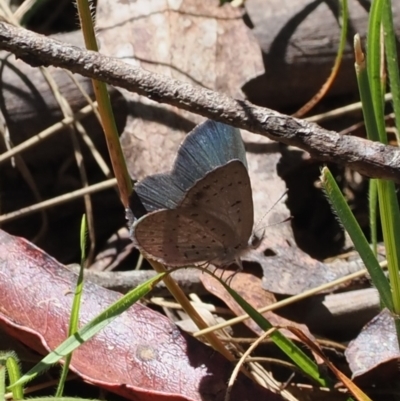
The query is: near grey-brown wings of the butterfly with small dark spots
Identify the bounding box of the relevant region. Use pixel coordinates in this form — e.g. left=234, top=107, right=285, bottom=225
left=133, top=160, right=253, bottom=266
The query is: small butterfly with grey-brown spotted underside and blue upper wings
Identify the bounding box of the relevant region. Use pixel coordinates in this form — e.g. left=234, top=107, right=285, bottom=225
left=131, top=120, right=254, bottom=267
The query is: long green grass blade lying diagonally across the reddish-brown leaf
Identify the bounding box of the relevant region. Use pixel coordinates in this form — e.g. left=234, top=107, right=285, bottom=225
left=10, top=273, right=167, bottom=387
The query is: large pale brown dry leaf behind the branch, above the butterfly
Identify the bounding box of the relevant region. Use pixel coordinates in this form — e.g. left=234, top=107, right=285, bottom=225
left=97, top=0, right=264, bottom=179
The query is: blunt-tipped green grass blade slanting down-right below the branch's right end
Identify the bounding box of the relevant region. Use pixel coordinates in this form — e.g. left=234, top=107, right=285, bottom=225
left=321, top=167, right=393, bottom=311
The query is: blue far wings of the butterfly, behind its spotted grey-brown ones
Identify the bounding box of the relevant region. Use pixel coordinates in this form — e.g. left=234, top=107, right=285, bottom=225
left=135, top=120, right=247, bottom=211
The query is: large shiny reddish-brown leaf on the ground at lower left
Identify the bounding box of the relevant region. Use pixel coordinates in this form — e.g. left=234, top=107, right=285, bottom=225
left=0, top=231, right=281, bottom=401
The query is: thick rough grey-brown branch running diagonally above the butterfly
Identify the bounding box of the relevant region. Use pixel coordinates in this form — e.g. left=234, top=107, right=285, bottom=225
left=0, top=22, right=400, bottom=183
